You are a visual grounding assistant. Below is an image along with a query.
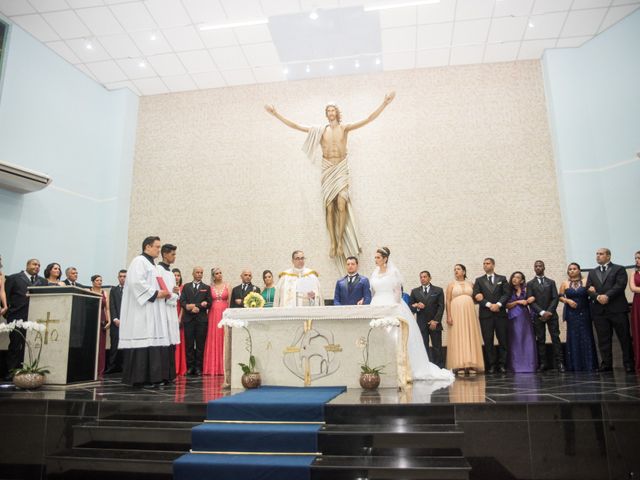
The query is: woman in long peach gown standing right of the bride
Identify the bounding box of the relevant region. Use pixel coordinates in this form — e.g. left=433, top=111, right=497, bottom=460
left=446, top=263, right=484, bottom=374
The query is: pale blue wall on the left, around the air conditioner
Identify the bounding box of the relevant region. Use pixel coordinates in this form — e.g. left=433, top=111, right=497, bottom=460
left=0, top=25, right=138, bottom=284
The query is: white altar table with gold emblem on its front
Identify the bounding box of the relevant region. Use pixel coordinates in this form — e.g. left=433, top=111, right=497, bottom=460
left=223, top=305, right=414, bottom=388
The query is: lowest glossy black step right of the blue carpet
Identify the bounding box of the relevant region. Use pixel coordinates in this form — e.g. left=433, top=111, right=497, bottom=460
left=311, top=455, right=471, bottom=480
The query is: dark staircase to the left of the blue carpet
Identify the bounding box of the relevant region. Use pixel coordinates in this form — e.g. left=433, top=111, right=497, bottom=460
left=46, top=403, right=206, bottom=480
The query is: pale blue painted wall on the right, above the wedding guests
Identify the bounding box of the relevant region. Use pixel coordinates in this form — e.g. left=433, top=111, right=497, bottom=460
left=543, top=11, right=640, bottom=266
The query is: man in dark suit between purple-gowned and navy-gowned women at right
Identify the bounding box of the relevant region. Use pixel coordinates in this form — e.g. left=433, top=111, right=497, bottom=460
left=527, top=260, right=564, bottom=373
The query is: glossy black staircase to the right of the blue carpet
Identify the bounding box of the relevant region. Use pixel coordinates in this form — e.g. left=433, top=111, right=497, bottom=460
left=311, top=404, right=471, bottom=480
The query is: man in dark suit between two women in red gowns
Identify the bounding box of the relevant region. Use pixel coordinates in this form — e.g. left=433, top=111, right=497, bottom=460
left=180, top=267, right=213, bottom=376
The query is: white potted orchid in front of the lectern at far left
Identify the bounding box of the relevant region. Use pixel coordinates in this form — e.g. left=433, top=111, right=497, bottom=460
left=0, top=320, right=49, bottom=389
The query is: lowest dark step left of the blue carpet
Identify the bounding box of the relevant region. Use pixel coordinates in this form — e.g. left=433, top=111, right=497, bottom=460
left=46, top=448, right=184, bottom=478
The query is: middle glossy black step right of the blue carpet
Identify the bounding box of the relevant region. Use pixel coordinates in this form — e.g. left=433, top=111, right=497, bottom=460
left=318, top=424, right=464, bottom=456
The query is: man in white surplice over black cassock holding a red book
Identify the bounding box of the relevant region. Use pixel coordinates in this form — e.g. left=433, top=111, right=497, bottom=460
left=118, top=237, right=172, bottom=387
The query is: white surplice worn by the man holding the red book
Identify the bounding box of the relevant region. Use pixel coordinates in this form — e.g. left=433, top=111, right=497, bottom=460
left=118, top=255, right=170, bottom=350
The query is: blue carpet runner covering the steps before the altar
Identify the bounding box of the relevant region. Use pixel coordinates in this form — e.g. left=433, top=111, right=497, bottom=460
left=173, top=386, right=345, bottom=480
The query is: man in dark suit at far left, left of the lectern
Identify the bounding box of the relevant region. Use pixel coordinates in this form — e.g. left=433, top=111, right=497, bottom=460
left=5, top=258, right=48, bottom=380
